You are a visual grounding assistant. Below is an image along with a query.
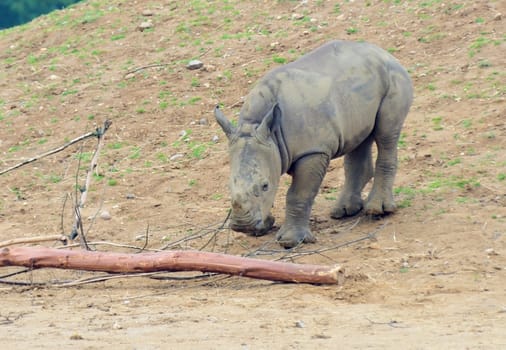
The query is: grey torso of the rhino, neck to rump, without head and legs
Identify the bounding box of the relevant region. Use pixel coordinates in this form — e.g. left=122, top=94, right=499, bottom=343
left=239, top=41, right=411, bottom=162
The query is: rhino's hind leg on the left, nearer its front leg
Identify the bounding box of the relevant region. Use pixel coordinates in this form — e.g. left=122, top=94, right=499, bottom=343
left=330, top=136, right=373, bottom=219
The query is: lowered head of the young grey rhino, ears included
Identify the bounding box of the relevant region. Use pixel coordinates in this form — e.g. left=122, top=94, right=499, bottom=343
left=214, top=106, right=281, bottom=236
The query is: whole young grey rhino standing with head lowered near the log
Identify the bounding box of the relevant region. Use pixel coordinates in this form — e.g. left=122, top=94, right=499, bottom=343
left=215, top=41, right=413, bottom=248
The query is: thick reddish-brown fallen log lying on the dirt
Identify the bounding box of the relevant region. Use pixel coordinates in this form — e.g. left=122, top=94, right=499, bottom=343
left=0, top=247, right=344, bottom=284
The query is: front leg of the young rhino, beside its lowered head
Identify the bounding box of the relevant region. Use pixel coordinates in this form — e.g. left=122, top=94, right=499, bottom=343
left=276, top=154, right=329, bottom=248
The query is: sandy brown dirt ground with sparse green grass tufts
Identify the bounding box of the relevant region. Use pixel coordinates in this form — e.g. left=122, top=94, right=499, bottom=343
left=0, top=0, right=506, bottom=349
